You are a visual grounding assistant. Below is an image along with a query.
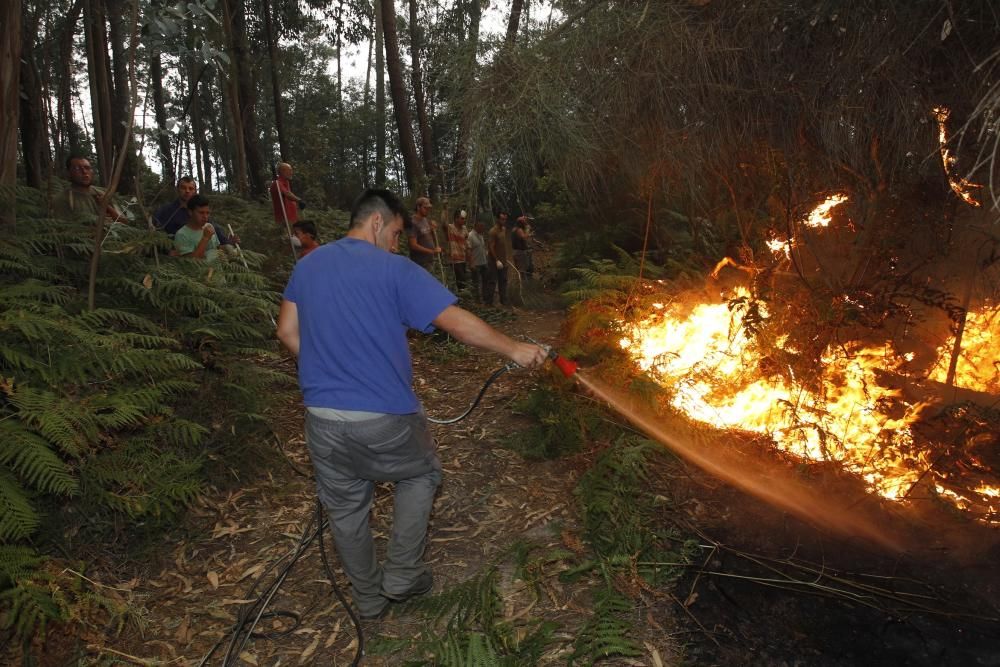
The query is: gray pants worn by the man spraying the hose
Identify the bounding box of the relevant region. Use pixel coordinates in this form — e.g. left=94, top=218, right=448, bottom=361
left=306, top=412, right=441, bottom=614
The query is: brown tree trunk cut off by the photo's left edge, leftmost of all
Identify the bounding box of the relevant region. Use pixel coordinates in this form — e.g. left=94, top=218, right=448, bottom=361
left=0, top=0, right=21, bottom=225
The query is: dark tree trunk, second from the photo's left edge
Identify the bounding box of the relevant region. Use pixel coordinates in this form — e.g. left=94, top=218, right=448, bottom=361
left=15, top=7, right=51, bottom=188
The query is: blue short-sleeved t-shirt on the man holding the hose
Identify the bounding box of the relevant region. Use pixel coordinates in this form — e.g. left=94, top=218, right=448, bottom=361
left=285, top=237, right=458, bottom=414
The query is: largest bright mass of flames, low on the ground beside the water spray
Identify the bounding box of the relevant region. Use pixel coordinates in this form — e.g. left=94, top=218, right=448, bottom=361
left=619, top=288, right=1000, bottom=516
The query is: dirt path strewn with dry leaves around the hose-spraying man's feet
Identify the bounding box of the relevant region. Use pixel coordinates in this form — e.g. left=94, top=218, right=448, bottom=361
left=107, top=311, right=667, bottom=665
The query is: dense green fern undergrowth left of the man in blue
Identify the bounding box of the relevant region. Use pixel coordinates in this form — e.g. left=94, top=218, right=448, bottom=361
left=0, top=188, right=293, bottom=645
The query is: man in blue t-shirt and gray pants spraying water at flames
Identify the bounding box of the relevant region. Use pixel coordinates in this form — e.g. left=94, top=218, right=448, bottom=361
left=278, top=190, right=545, bottom=618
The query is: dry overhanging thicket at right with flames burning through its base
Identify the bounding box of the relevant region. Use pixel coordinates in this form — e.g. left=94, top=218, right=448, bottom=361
left=469, top=0, right=1000, bottom=521
